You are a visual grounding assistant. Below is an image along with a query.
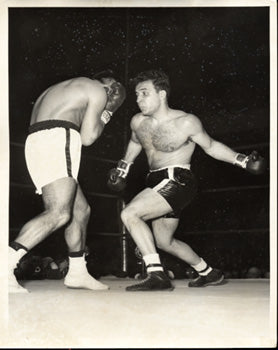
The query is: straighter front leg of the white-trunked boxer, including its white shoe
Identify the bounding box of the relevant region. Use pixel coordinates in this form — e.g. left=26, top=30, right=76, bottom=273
left=64, top=185, right=108, bottom=290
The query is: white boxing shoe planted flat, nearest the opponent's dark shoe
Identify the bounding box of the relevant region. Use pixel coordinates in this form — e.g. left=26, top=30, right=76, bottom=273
left=64, top=254, right=109, bottom=290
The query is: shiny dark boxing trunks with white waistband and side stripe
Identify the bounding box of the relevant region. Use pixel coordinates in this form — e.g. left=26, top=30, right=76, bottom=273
left=146, top=167, right=197, bottom=218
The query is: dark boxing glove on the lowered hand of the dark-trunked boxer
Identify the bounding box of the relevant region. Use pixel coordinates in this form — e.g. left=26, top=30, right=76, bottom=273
left=107, top=160, right=132, bottom=192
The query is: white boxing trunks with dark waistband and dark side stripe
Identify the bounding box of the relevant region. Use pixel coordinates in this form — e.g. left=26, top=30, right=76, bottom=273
left=25, top=120, right=82, bottom=194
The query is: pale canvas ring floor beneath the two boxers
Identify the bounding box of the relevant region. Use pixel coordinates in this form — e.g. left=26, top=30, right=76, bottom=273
left=6, top=276, right=272, bottom=348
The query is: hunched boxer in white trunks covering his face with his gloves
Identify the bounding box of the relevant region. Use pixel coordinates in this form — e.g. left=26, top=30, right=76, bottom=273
left=9, top=72, right=125, bottom=292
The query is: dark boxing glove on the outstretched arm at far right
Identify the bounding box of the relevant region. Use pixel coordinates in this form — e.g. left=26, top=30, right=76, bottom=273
left=234, top=151, right=266, bottom=175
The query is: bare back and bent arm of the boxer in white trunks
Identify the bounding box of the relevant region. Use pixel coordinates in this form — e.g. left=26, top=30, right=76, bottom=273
left=30, top=77, right=108, bottom=146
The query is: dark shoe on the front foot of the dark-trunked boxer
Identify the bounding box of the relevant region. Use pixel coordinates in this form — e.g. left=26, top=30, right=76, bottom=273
left=126, top=271, right=174, bottom=292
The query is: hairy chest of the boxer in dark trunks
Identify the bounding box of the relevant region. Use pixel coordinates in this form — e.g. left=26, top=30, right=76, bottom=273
left=136, top=119, right=190, bottom=152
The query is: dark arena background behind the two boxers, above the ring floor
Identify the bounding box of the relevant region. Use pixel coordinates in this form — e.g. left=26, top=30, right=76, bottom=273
left=9, top=7, right=270, bottom=277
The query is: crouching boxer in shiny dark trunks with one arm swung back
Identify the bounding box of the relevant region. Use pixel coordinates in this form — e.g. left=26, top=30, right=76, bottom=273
left=108, top=71, right=265, bottom=291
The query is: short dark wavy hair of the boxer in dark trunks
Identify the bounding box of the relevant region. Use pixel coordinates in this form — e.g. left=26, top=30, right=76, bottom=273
left=132, top=69, right=170, bottom=97
